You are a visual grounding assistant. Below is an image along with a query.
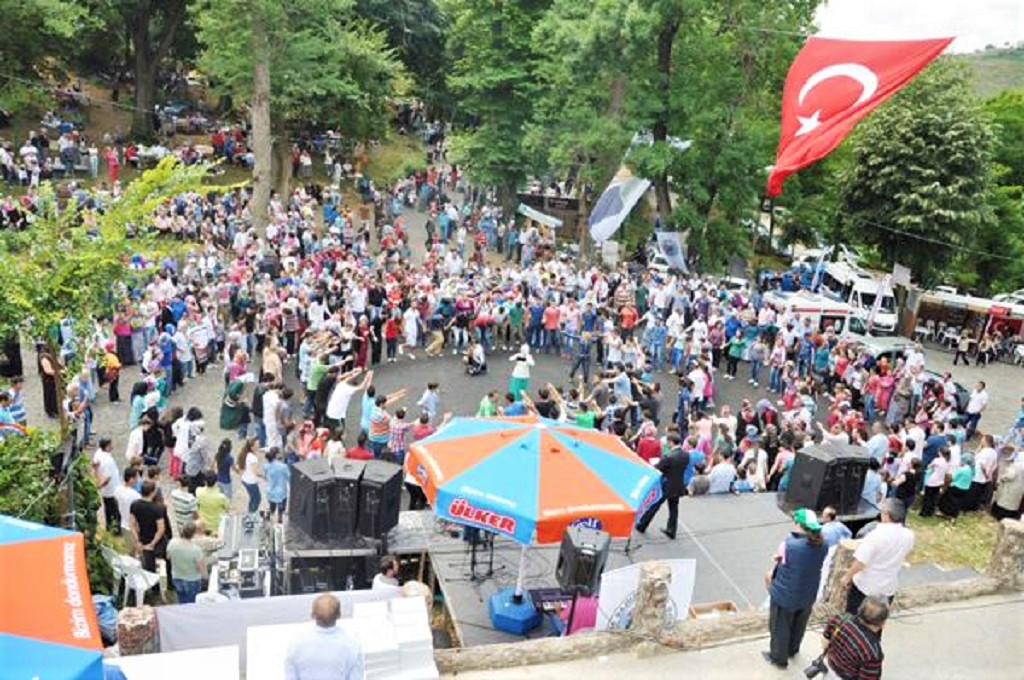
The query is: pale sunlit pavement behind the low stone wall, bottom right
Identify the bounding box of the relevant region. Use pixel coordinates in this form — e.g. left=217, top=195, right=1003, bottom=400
left=444, top=594, right=1024, bottom=680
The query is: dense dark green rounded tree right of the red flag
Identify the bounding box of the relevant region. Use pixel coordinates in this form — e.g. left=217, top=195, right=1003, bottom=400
left=841, top=59, right=994, bottom=285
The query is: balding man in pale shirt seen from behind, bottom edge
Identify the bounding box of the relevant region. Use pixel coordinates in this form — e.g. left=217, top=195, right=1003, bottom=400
left=285, top=593, right=365, bottom=680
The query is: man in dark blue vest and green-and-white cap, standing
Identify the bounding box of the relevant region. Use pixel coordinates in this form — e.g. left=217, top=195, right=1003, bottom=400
left=762, top=508, right=828, bottom=668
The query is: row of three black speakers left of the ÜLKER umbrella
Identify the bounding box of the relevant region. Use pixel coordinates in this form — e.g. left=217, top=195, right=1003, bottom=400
left=288, top=458, right=401, bottom=543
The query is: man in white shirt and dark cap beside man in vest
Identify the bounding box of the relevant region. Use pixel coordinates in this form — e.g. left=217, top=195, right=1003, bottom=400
left=843, top=499, right=913, bottom=613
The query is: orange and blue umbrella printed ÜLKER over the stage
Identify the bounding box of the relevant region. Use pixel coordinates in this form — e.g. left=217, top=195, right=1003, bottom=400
left=406, top=416, right=662, bottom=546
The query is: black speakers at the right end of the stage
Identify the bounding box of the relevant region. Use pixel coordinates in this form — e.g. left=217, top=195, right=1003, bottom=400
left=785, top=443, right=871, bottom=515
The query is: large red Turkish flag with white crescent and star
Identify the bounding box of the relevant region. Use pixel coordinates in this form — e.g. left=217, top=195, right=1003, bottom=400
left=768, top=38, right=953, bottom=196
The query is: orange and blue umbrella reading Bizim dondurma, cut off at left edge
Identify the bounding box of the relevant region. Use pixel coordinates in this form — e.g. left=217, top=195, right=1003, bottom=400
left=0, top=515, right=103, bottom=680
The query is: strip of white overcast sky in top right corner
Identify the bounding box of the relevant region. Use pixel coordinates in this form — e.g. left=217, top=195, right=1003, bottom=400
left=818, top=0, right=1024, bottom=52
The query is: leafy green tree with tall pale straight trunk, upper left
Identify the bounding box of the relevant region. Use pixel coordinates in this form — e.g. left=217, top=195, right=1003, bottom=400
left=196, top=0, right=401, bottom=228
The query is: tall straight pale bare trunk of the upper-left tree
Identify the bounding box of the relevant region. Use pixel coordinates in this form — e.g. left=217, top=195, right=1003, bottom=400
left=251, top=16, right=273, bottom=233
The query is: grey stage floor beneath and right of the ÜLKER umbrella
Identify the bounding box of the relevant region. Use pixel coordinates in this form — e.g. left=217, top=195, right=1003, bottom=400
left=388, top=494, right=792, bottom=646
